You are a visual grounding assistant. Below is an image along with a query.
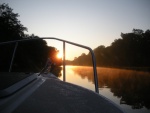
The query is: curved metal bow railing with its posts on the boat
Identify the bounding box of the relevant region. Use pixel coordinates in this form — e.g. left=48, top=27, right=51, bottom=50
left=0, top=37, right=99, bottom=93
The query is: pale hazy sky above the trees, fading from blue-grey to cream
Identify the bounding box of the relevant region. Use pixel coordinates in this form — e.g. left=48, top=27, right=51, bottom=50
left=0, top=0, right=150, bottom=59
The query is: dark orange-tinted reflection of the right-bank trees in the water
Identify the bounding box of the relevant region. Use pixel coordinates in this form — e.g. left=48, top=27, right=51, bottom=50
left=73, top=67, right=150, bottom=109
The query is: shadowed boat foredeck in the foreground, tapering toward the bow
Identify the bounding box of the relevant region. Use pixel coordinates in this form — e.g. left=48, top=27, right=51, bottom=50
left=1, top=75, right=123, bottom=113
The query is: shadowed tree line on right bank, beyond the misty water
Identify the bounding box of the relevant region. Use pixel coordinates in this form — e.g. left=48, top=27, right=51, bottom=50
left=67, top=29, right=150, bottom=67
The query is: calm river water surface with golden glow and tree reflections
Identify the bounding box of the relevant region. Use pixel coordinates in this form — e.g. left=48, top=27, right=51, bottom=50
left=60, top=66, right=150, bottom=113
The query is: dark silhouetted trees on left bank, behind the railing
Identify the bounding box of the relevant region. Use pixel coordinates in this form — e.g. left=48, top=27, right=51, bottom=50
left=0, top=3, right=62, bottom=72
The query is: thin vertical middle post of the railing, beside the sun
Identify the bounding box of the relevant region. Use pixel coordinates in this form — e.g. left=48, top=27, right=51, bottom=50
left=63, top=41, right=66, bottom=81
